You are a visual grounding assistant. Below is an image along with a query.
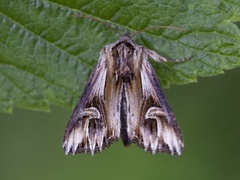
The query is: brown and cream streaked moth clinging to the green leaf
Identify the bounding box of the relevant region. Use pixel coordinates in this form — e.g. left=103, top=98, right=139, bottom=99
left=62, top=35, right=184, bottom=155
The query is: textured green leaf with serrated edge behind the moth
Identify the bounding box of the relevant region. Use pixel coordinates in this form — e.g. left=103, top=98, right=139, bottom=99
left=0, top=0, right=240, bottom=112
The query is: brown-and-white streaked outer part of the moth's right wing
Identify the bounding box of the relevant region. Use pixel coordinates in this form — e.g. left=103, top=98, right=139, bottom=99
left=131, top=52, right=184, bottom=155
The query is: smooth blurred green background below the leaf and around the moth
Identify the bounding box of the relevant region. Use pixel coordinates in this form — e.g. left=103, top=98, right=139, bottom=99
left=0, top=68, right=240, bottom=180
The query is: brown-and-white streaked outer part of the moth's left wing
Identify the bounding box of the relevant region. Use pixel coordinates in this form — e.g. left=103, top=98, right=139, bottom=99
left=63, top=53, right=120, bottom=155
